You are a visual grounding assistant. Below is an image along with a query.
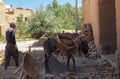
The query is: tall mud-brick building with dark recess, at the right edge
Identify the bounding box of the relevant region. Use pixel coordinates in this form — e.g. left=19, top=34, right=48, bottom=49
left=82, top=0, right=120, bottom=71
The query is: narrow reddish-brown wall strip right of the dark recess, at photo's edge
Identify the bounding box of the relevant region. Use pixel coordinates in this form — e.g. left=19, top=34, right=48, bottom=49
left=115, top=0, right=120, bottom=54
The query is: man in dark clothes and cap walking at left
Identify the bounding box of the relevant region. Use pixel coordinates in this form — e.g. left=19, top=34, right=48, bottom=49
left=4, top=22, right=19, bottom=69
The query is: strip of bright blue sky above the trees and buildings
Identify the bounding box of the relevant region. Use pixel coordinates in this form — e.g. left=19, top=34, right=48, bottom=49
left=3, top=0, right=82, bottom=10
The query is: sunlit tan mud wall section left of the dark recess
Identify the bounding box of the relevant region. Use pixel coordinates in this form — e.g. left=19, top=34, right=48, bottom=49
left=83, top=0, right=99, bottom=50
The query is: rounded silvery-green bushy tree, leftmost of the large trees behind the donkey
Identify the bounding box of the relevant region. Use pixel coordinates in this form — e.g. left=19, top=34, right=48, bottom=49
left=27, top=10, right=58, bottom=34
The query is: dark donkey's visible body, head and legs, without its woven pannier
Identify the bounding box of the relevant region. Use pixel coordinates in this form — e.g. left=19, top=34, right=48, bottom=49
left=43, top=38, right=89, bottom=72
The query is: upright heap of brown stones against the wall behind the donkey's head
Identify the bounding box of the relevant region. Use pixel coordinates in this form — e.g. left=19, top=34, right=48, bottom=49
left=81, top=23, right=100, bottom=58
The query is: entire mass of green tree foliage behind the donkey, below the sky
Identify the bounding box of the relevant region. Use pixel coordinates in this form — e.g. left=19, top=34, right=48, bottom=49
left=27, top=0, right=82, bottom=34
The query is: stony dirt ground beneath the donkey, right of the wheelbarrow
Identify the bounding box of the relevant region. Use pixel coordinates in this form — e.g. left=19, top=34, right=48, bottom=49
left=46, top=57, right=120, bottom=79
